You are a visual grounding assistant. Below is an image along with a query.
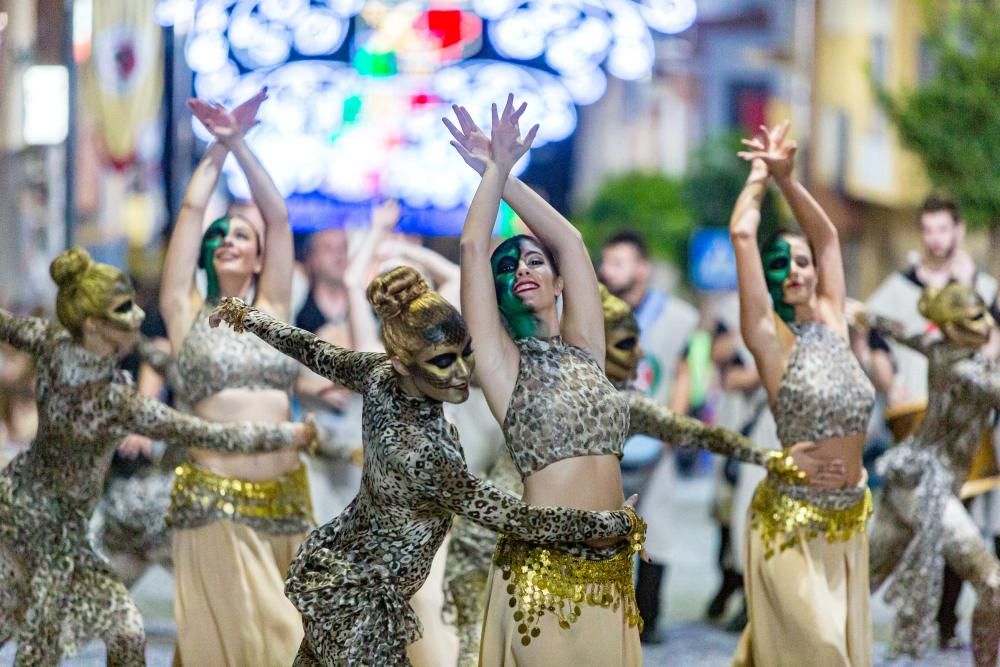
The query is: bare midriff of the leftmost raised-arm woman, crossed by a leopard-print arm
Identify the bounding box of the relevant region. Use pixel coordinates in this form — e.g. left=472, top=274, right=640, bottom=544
left=189, top=389, right=300, bottom=482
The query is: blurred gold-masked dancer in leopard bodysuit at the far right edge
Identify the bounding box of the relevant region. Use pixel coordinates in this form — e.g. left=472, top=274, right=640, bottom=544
left=871, top=283, right=1000, bottom=667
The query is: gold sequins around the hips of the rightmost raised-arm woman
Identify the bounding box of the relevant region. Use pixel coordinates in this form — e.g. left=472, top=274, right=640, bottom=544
left=750, top=477, right=872, bottom=559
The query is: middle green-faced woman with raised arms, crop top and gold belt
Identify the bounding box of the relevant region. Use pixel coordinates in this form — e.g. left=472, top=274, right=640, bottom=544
left=445, top=96, right=644, bottom=667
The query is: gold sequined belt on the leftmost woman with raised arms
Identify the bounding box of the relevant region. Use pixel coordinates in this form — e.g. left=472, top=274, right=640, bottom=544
left=168, top=462, right=312, bottom=523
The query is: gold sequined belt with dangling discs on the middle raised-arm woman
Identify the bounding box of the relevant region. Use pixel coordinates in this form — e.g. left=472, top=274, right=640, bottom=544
left=493, top=536, right=642, bottom=646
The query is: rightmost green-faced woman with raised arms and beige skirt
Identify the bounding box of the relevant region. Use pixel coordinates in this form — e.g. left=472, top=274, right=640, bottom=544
left=729, top=122, right=875, bottom=667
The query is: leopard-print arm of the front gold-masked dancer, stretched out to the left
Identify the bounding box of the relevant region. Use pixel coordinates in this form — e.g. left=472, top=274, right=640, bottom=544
left=209, top=298, right=386, bottom=393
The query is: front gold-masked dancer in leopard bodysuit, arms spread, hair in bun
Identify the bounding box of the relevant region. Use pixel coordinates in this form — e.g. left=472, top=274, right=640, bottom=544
left=214, top=267, right=642, bottom=666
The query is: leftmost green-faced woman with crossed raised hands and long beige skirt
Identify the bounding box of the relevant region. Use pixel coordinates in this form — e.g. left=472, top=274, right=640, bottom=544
left=160, top=91, right=312, bottom=666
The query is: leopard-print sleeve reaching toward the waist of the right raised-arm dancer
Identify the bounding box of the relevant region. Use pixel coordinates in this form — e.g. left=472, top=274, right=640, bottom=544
left=623, top=391, right=773, bottom=466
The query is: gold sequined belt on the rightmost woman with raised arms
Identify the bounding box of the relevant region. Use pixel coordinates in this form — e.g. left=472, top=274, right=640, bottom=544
left=750, top=476, right=872, bottom=559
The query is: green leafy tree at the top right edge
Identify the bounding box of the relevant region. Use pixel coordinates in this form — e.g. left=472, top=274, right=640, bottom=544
left=873, top=0, right=1000, bottom=273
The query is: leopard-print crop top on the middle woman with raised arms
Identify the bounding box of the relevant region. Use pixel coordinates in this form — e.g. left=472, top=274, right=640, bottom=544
left=503, top=337, right=629, bottom=477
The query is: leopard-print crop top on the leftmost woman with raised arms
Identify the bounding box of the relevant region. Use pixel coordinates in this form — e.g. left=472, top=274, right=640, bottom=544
left=169, top=303, right=299, bottom=411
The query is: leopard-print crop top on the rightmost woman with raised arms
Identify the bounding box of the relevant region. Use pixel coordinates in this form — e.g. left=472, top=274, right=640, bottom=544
left=772, top=322, right=875, bottom=447
